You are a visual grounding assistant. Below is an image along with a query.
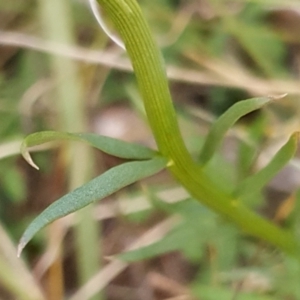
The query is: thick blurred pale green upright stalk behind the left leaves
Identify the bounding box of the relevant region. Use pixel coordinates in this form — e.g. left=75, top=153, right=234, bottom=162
left=40, top=0, right=101, bottom=299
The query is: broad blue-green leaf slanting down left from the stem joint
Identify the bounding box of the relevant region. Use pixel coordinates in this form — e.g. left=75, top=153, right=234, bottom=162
left=18, top=157, right=167, bottom=255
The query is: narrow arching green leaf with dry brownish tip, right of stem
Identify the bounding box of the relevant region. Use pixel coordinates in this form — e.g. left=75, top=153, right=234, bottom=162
left=199, top=97, right=274, bottom=165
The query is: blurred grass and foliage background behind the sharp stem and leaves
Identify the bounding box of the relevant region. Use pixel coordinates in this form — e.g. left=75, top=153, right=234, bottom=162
left=0, top=0, right=300, bottom=300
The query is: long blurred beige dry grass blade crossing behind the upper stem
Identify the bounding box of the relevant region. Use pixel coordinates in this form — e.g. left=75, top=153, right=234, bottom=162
left=0, top=31, right=300, bottom=95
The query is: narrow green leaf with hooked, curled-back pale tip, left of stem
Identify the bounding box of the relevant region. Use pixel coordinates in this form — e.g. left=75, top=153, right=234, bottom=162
left=21, top=131, right=157, bottom=169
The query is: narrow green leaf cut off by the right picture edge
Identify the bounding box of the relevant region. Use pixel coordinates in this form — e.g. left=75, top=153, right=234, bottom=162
left=234, top=132, right=300, bottom=198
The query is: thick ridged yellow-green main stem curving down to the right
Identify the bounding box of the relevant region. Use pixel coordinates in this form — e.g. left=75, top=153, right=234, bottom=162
left=98, top=0, right=299, bottom=255
